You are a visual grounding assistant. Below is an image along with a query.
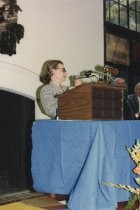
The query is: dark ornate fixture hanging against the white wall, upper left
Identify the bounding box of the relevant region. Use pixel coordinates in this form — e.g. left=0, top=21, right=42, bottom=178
left=0, top=0, right=24, bottom=56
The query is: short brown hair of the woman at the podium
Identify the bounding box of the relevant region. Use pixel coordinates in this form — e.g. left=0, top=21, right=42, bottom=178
left=40, top=60, right=63, bottom=84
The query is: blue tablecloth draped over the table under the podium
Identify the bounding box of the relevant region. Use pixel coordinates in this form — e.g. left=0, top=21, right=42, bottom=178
left=32, top=120, right=140, bottom=210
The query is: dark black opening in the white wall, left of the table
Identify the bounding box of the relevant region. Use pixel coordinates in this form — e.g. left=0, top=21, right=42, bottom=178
left=0, top=90, right=35, bottom=196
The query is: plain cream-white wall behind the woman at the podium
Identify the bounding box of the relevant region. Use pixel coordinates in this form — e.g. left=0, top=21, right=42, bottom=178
left=0, top=0, right=104, bottom=118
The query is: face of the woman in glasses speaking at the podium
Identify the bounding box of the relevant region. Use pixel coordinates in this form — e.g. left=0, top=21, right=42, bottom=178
left=52, top=63, right=67, bottom=83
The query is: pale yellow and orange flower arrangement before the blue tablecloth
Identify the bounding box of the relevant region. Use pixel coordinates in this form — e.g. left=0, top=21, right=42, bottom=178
left=104, top=139, right=140, bottom=210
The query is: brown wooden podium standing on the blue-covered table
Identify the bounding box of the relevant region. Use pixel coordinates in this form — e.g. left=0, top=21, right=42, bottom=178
left=58, top=83, right=123, bottom=120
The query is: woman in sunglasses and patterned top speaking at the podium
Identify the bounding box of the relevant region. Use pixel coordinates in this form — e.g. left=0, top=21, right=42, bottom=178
left=40, top=60, right=82, bottom=119
